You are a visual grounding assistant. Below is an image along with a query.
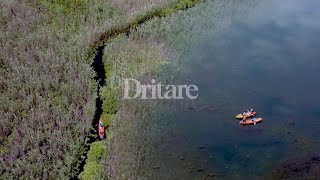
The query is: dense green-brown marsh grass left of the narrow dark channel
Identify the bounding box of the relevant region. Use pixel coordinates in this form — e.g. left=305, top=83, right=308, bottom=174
left=0, top=0, right=174, bottom=179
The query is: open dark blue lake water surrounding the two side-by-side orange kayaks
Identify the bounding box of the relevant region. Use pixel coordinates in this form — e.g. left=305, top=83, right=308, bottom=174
left=157, top=0, right=320, bottom=179
